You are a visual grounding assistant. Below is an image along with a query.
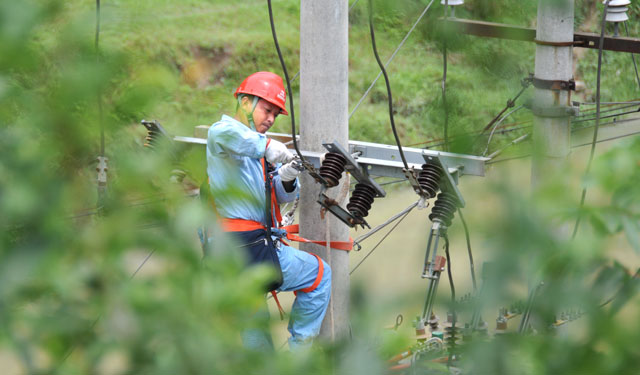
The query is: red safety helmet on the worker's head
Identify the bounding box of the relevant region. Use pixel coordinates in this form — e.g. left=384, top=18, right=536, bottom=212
left=233, top=72, right=289, bottom=115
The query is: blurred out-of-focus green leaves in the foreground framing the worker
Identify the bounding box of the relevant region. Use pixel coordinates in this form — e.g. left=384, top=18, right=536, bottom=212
left=0, top=1, right=640, bottom=374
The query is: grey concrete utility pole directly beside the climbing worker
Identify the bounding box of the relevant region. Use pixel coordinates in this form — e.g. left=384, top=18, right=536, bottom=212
left=300, top=0, right=349, bottom=340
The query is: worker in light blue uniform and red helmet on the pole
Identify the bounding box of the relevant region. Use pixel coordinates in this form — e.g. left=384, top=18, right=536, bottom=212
left=207, top=72, right=331, bottom=350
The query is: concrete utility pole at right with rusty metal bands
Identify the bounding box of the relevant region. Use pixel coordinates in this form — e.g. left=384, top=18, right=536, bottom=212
left=531, top=0, right=574, bottom=189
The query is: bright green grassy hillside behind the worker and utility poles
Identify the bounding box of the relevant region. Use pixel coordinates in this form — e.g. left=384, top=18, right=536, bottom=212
left=45, top=0, right=639, bottom=173
